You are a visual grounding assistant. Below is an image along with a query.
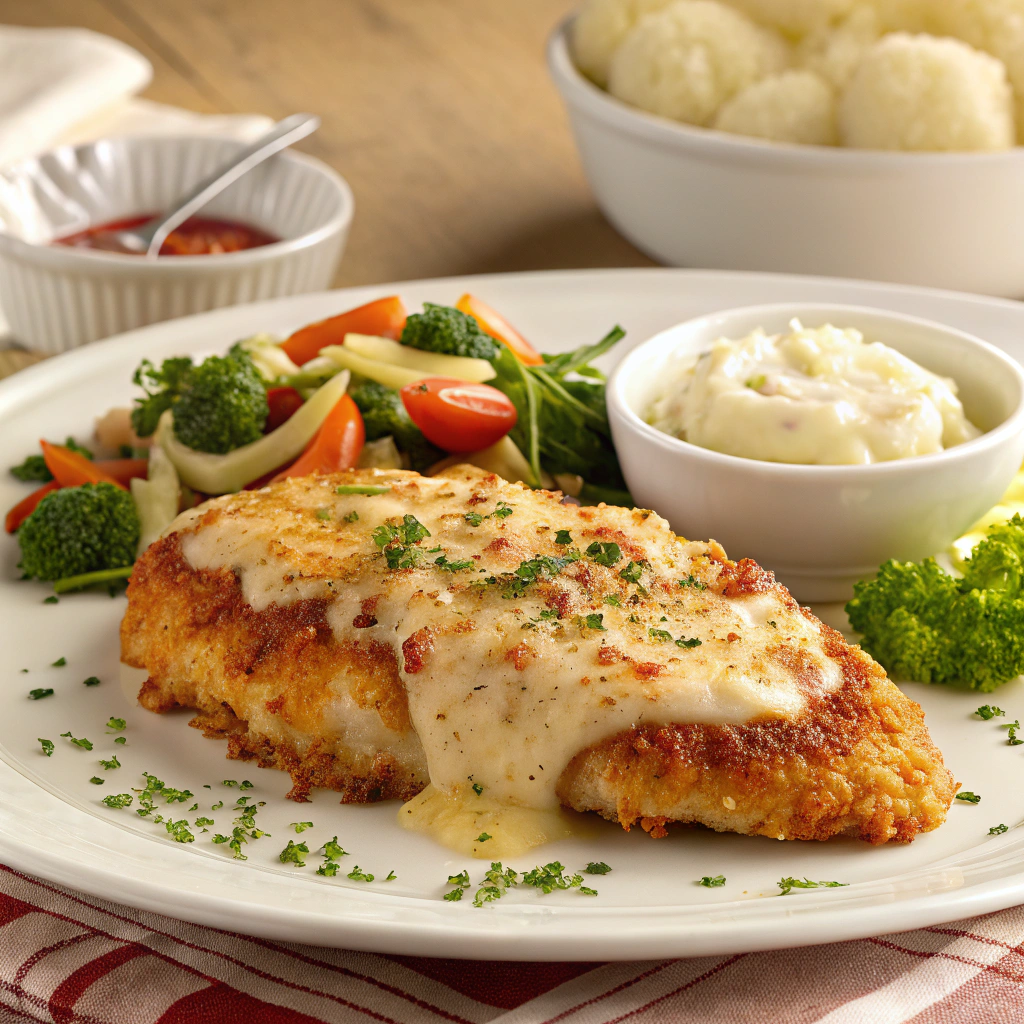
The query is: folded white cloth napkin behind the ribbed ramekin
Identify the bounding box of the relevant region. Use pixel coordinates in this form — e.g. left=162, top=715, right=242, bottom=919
left=0, top=25, right=272, bottom=344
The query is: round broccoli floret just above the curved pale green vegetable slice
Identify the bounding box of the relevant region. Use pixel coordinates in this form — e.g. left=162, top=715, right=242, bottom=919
left=172, top=352, right=269, bottom=455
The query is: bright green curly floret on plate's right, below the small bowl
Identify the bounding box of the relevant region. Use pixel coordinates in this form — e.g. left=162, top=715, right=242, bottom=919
left=846, top=516, right=1024, bottom=691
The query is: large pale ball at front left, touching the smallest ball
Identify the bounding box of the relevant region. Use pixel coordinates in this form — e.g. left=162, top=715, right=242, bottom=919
left=608, top=0, right=792, bottom=125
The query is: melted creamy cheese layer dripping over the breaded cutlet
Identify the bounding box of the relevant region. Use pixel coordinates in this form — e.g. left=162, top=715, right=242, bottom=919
left=180, top=472, right=842, bottom=856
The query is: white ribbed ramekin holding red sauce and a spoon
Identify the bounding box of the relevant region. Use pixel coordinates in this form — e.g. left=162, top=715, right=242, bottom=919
left=0, top=137, right=354, bottom=353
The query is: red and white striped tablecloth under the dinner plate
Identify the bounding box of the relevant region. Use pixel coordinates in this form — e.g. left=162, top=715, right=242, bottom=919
left=0, top=866, right=1024, bottom=1024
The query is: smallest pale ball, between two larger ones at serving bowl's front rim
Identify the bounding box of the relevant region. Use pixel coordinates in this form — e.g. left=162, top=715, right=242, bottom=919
left=714, top=71, right=839, bottom=145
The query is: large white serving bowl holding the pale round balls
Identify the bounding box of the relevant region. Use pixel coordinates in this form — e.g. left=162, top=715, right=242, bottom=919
left=548, top=18, right=1024, bottom=298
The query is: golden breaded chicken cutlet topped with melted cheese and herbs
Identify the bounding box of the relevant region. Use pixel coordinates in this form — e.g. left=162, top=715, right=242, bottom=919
left=121, top=466, right=957, bottom=844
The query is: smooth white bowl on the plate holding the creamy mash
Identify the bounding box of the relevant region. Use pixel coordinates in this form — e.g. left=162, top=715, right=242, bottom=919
left=608, top=304, right=1024, bottom=602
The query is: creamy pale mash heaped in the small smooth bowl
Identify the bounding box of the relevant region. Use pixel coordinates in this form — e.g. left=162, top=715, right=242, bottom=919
left=647, top=321, right=980, bottom=465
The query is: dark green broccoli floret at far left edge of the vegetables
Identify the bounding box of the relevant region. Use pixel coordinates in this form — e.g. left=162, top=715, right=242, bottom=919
left=17, top=483, right=139, bottom=580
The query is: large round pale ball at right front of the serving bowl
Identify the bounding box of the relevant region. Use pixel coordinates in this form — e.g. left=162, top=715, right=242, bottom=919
left=839, top=33, right=1015, bottom=152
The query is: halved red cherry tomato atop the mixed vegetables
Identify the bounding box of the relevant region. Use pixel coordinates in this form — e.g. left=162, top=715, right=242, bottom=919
left=401, top=377, right=517, bottom=452
